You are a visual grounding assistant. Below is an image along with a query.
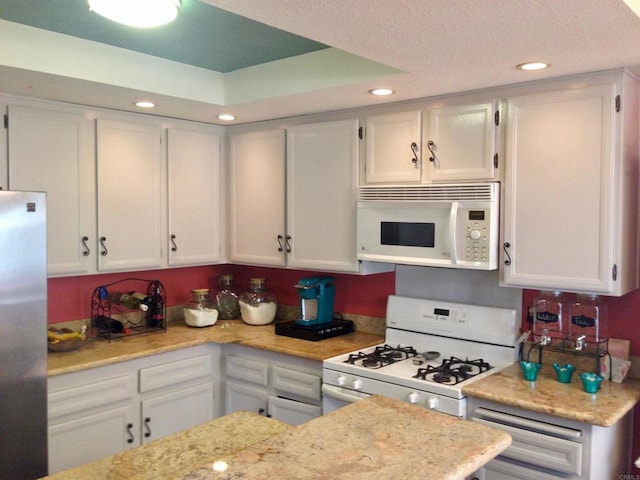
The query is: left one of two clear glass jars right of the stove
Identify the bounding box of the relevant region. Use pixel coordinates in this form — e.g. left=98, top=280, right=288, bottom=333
left=533, top=292, right=568, bottom=347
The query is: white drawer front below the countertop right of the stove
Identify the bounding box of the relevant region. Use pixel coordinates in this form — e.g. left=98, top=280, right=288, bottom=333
left=473, top=418, right=582, bottom=475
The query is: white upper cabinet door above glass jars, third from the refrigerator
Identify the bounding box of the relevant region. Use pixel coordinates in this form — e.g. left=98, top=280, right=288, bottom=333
left=167, top=128, right=221, bottom=266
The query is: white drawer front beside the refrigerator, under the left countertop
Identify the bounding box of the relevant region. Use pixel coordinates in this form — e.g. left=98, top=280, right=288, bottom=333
left=47, top=373, right=136, bottom=420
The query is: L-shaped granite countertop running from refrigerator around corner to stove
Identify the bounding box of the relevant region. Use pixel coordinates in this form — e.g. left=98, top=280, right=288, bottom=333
left=47, top=320, right=384, bottom=376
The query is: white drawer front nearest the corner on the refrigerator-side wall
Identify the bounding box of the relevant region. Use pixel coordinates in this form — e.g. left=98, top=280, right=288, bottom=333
left=140, top=355, right=213, bottom=393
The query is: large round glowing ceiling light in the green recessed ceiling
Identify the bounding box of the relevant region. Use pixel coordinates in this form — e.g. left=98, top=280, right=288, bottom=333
left=89, top=0, right=180, bottom=28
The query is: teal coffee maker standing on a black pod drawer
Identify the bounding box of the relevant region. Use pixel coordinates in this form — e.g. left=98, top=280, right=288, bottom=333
left=295, top=275, right=336, bottom=327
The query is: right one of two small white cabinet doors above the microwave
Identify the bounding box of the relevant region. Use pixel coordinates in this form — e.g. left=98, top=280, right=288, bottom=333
left=424, top=103, right=498, bottom=182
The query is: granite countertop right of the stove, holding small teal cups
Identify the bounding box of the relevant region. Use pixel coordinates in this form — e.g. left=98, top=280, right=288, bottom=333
left=462, top=363, right=640, bottom=427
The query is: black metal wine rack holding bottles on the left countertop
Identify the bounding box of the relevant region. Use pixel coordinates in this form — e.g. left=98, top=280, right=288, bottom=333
left=91, top=278, right=167, bottom=341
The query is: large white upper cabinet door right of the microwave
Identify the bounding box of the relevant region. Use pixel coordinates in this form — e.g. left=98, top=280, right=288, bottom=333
left=502, top=85, right=615, bottom=293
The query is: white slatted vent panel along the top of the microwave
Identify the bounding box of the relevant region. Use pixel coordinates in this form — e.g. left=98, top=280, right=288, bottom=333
left=358, top=182, right=498, bottom=202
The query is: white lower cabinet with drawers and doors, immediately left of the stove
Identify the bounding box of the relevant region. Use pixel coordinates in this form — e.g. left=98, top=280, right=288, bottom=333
left=224, top=345, right=322, bottom=425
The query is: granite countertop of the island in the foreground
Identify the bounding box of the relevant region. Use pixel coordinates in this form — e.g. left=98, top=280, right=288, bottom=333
left=42, top=396, right=511, bottom=480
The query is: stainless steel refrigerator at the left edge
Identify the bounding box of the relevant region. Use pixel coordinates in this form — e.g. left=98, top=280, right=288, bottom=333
left=0, top=191, right=48, bottom=480
